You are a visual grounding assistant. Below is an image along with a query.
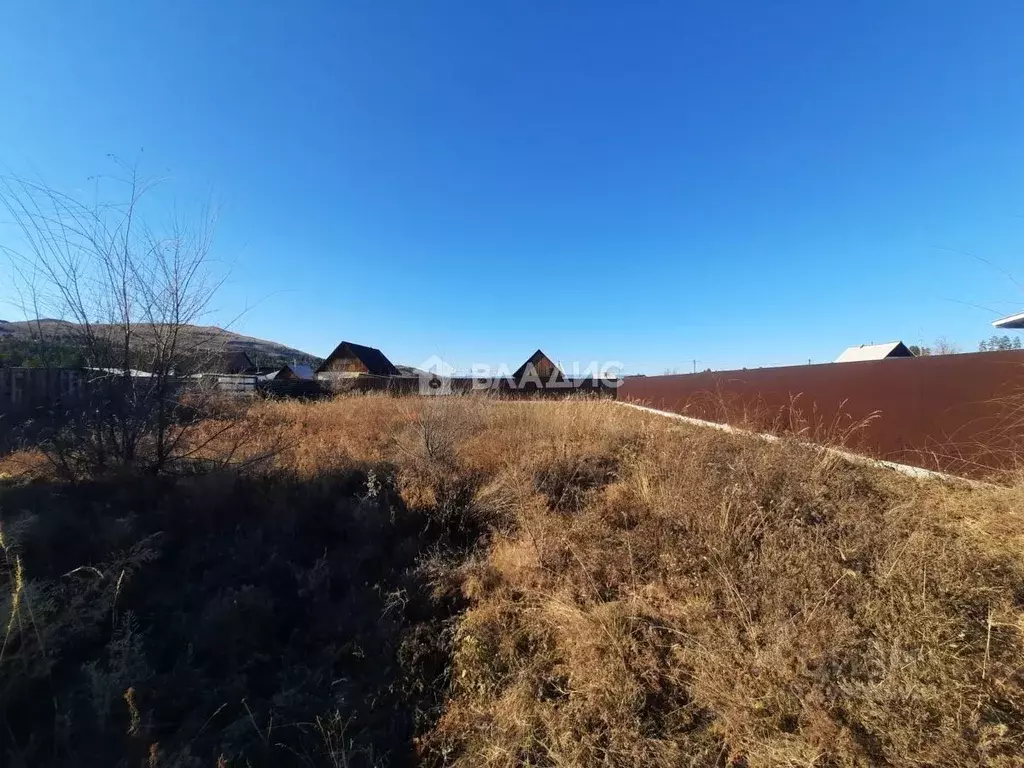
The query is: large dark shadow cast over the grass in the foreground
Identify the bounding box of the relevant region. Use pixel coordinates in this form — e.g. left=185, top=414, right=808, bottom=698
left=0, top=465, right=474, bottom=767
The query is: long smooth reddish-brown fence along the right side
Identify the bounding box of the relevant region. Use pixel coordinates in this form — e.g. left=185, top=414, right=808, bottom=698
left=618, top=351, right=1024, bottom=474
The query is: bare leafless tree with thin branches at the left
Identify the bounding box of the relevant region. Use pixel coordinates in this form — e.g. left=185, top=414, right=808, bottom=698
left=0, top=163, right=233, bottom=475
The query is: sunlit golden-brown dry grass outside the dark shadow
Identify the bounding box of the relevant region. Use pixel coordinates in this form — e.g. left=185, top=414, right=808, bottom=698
left=6, top=395, right=1024, bottom=768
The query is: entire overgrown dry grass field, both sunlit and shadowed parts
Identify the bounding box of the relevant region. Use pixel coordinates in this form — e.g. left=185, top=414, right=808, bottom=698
left=0, top=395, right=1024, bottom=768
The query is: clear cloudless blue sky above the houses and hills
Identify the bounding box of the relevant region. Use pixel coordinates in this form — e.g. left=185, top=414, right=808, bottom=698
left=0, top=0, right=1024, bottom=373
